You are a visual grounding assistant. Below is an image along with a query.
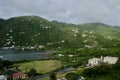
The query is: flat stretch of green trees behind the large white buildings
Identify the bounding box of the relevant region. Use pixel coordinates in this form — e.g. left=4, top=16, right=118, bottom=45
left=52, top=47, right=120, bottom=67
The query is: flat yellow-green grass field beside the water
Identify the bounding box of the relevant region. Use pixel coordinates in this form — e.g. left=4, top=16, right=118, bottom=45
left=18, top=60, right=62, bottom=73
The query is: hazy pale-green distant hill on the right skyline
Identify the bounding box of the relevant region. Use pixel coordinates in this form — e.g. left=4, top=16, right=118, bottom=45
left=79, top=23, right=120, bottom=40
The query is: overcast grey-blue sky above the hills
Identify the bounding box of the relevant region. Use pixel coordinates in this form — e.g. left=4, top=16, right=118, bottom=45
left=0, top=0, right=120, bottom=26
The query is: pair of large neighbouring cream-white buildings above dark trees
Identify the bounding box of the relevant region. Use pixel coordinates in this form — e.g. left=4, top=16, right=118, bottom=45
left=87, top=56, right=118, bottom=67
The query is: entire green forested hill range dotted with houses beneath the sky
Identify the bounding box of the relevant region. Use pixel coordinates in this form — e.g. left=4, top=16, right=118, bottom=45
left=0, top=16, right=120, bottom=50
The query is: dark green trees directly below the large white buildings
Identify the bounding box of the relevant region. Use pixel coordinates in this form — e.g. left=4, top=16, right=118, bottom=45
left=83, top=62, right=120, bottom=80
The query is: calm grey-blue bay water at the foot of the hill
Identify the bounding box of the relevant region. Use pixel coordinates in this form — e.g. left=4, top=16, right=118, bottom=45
left=0, top=50, right=55, bottom=61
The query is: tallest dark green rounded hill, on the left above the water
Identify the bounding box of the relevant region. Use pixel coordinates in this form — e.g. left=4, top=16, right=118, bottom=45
left=0, top=16, right=66, bottom=49
